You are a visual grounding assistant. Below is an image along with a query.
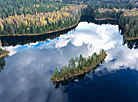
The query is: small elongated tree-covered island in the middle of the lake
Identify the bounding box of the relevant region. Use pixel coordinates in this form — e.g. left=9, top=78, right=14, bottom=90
left=51, top=49, right=107, bottom=82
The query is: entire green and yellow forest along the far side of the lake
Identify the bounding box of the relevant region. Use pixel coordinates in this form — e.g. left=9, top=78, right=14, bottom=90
left=0, top=0, right=138, bottom=40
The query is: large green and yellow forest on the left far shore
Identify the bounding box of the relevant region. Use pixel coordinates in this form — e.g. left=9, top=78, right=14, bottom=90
left=0, top=0, right=86, bottom=35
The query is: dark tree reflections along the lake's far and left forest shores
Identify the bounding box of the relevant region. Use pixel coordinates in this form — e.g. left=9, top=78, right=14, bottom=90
left=0, top=16, right=118, bottom=46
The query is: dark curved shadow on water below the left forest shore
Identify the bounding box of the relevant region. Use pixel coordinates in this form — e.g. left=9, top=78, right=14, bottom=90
left=0, top=25, right=77, bottom=46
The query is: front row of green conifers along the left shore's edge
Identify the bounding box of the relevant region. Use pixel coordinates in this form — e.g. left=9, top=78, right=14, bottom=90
left=0, top=18, right=78, bottom=35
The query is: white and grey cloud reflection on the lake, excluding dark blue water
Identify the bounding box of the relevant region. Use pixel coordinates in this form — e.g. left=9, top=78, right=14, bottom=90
left=0, top=22, right=138, bottom=102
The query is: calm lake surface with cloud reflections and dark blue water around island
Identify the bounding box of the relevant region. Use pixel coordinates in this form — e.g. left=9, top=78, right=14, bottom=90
left=0, top=22, right=138, bottom=102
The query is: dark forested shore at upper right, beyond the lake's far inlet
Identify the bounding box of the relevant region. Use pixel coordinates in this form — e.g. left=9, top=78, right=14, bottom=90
left=82, top=0, right=138, bottom=40
